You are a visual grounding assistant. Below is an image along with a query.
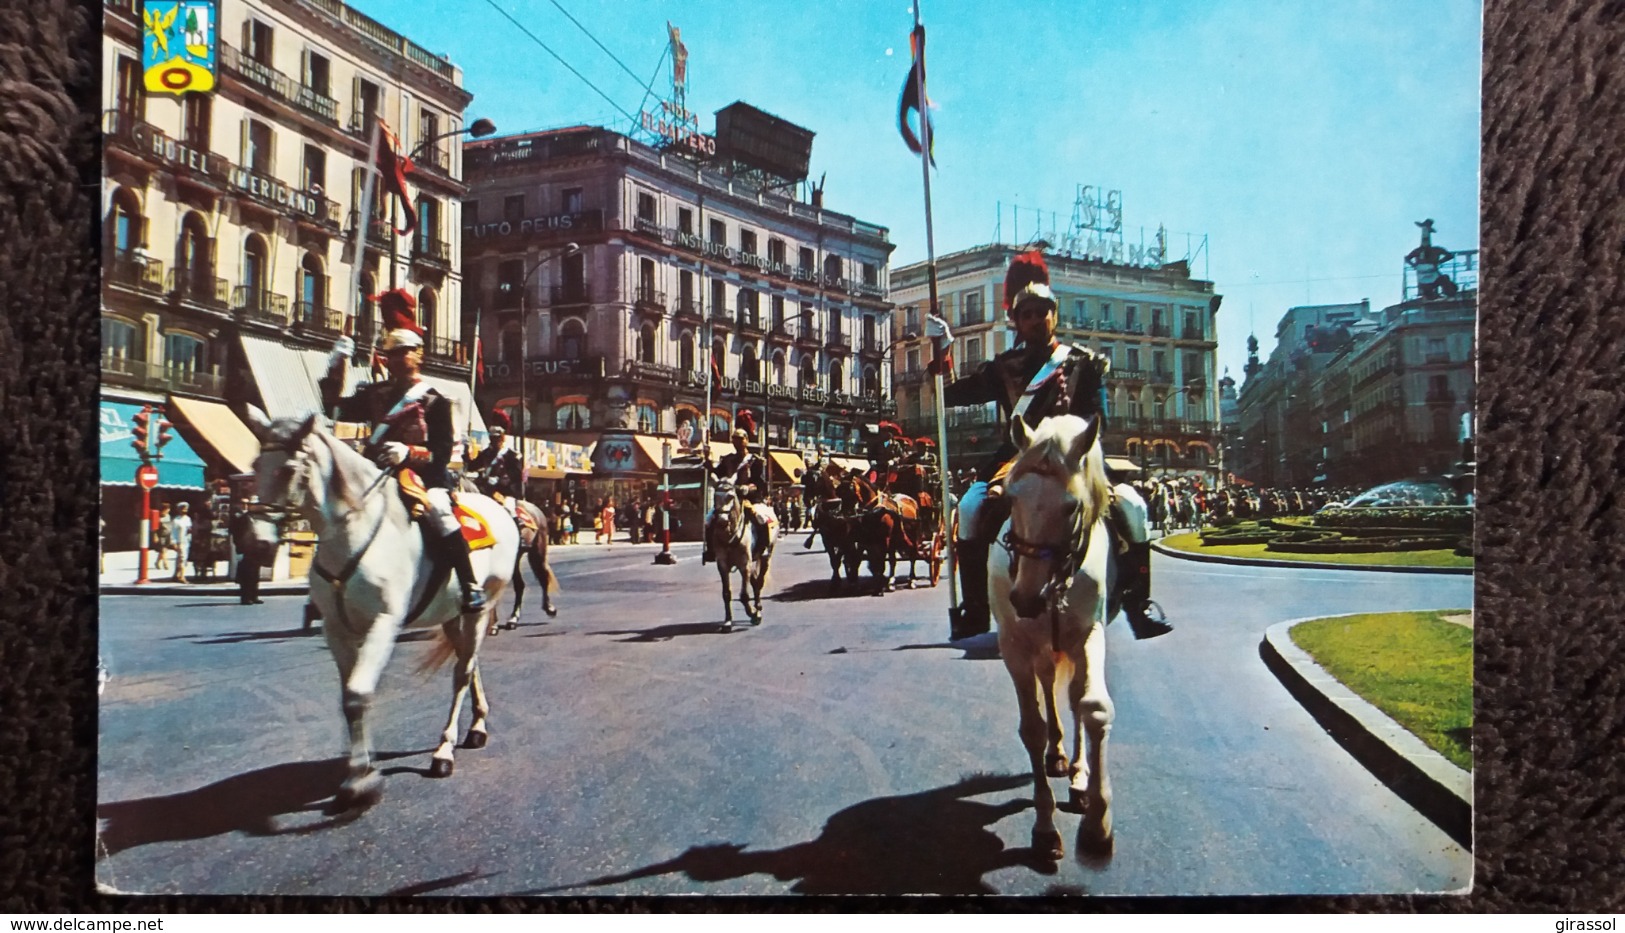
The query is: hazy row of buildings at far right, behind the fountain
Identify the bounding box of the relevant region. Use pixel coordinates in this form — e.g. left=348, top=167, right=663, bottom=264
left=1230, top=224, right=1479, bottom=488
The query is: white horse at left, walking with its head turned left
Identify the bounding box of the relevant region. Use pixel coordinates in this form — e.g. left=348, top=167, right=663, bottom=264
left=249, top=406, right=518, bottom=809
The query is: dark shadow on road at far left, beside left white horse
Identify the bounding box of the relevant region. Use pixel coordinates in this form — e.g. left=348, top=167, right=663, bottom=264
left=96, top=757, right=346, bottom=858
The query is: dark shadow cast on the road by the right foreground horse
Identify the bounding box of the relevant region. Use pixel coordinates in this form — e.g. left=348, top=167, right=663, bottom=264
left=525, top=775, right=1056, bottom=894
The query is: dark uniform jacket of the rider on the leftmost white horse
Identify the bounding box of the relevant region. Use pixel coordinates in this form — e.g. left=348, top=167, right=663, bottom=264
left=319, top=367, right=457, bottom=489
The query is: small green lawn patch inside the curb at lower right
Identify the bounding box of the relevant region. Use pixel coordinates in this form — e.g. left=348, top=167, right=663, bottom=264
left=1292, top=611, right=1472, bottom=770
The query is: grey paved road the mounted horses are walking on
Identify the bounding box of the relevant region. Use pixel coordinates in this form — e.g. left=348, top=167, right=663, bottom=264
left=98, top=538, right=1472, bottom=896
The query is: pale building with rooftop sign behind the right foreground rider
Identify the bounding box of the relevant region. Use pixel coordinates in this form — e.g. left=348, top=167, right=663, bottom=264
left=891, top=244, right=1220, bottom=483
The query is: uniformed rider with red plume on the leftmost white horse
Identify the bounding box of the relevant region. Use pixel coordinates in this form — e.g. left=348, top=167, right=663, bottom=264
left=319, top=289, right=486, bottom=613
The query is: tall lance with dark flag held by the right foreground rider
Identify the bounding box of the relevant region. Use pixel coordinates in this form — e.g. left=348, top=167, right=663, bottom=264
left=897, top=0, right=959, bottom=627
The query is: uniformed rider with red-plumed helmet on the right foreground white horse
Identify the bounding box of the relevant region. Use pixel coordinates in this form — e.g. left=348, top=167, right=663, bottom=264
left=931, top=250, right=1172, bottom=639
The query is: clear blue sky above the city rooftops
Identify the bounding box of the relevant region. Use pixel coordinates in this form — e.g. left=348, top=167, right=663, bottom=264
left=349, top=0, right=1482, bottom=379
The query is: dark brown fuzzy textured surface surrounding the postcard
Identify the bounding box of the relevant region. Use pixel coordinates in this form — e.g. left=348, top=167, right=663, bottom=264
left=0, top=0, right=1625, bottom=912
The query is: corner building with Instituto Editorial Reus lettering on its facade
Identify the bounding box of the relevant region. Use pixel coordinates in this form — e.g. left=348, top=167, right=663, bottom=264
left=463, top=117, right=895, bottom=513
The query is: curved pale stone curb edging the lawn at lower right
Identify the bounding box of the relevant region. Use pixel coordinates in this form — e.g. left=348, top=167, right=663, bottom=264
left=1258, top=613, right=1472, bottom=850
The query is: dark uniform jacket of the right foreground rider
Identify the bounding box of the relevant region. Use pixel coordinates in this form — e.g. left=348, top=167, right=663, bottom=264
left=943, top=339, right=1110, bottom=481
